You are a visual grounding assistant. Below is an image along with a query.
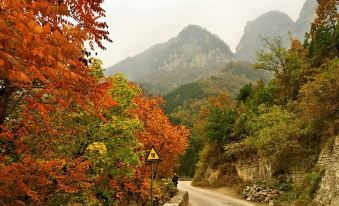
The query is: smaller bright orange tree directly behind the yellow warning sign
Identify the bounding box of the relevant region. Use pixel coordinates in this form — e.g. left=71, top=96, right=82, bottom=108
left=137, top=97, right=189, bottom=178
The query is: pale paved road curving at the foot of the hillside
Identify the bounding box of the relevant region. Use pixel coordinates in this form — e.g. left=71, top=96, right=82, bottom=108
left=178, top=181, right=254, bottom=206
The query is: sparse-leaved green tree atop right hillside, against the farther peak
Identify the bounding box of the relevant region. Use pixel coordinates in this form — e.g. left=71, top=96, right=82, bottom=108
left=254, top=38, right=312, bottom=104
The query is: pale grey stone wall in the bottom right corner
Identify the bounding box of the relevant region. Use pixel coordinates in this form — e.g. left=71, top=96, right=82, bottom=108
left=314, top=136, right=339, bottom=206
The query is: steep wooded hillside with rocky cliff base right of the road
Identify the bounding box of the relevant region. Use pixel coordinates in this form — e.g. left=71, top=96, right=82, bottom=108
left=192, top=0, right=339, bottom=206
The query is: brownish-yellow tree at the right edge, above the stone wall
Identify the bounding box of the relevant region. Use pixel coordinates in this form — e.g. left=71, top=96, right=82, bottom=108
left=298, top=58, right=339, bottom=139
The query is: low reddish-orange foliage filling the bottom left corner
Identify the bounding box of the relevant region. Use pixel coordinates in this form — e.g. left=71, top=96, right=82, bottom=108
left=0, top=156, right=90, bottom=205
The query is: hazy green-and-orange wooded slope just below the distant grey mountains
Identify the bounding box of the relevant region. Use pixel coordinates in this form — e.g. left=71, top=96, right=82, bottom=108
left=164, top=61, right=271, bottom=126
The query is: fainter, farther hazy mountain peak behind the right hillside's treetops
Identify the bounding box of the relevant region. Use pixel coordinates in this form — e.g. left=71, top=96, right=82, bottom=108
left=236, top=0, right=317, bottom=62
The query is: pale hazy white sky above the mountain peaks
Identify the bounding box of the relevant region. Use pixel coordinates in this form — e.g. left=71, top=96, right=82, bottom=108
left=98, top=0, right=305, bottom=68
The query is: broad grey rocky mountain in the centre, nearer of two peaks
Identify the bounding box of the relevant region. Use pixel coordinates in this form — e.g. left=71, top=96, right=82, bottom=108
left=106, top=25, right=234, bottom=94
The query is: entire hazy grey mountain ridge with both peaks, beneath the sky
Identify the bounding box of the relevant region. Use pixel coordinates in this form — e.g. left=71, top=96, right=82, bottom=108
left=105, top=0, right=317, bottom=94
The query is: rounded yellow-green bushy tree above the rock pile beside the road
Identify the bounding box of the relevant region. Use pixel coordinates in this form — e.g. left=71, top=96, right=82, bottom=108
left=244, top=105, right=318, bottom=176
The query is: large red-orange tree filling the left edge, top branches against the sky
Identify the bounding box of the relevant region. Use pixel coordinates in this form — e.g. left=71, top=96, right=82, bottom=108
left=0, top=0, right=115, bottom=205
